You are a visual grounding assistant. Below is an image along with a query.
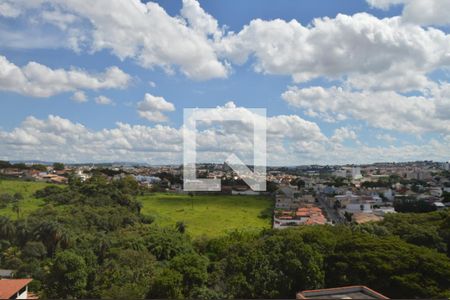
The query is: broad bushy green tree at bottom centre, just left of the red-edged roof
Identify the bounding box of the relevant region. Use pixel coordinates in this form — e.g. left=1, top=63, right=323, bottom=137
left=206, top=229, right=324, bottom=298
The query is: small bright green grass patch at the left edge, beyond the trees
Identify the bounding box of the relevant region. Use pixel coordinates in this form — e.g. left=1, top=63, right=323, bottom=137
left=0, top=179, right=49, bottom=219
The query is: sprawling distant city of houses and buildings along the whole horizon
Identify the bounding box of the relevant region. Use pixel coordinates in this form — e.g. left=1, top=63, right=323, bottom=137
left=0, top=161, right=450, bottom=229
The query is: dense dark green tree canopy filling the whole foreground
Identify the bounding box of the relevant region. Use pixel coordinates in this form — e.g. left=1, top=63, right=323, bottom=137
left=0, top=175, right=450, bottom=299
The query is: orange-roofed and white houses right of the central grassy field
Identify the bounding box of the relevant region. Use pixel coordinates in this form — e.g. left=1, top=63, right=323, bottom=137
left=269, top=162, right=450, bottom=228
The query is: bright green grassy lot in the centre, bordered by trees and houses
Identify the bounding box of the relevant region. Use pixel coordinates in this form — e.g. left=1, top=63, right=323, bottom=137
left=139, top=193, right=272, bottom=237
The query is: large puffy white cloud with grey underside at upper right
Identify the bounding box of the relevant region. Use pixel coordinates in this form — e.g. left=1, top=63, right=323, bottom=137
left=217, top=13, right=450, bottom=91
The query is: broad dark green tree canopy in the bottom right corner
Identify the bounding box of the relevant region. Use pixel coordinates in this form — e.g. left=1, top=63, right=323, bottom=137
left=325, top=234, right=450, bottom=298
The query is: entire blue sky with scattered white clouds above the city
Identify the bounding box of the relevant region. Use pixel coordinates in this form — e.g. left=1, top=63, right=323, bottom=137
left=0, top=0, right=450, bottom=164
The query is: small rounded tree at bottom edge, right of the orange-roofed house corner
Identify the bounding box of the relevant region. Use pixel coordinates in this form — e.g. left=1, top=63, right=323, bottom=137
left=47, top=251, right=88, bottom=298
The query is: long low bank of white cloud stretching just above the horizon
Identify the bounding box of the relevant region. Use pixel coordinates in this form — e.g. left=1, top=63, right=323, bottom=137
left=0, top=111, right=450, bottom=165
